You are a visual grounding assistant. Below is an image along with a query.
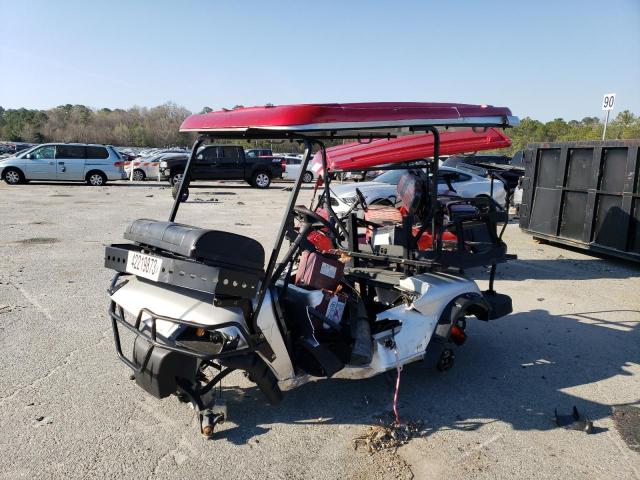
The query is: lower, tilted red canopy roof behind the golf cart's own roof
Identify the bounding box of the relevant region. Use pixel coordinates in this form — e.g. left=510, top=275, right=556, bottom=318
left=310, top=128, right=511, bottom=175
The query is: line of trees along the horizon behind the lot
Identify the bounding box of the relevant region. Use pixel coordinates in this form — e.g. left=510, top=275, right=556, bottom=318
left=0, top=102, right=640, bottom=153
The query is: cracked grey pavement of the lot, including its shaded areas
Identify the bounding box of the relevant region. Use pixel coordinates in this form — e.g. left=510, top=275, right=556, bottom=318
left=0, top=182, right=640, bottom=480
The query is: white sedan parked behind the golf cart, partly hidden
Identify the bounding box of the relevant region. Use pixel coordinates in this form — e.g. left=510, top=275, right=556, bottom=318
left=331, top=167, right=507, bottom=214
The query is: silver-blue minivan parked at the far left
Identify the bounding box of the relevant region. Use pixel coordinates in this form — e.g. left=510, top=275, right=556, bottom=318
left=0, top=143, right=126, bottom=186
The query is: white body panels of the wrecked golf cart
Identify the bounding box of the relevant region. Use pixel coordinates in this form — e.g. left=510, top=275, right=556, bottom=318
left=111, top=273, right=480, bottom=390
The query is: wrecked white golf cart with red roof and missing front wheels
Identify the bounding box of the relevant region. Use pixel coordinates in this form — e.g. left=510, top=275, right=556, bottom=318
left=105, top=103, right=517, bottom=436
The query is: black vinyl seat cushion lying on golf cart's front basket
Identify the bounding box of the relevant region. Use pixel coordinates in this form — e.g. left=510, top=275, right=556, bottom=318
left=124, top=219, right=264, bottom=273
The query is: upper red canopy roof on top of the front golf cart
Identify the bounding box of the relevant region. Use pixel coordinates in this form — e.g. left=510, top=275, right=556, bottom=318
left=180, top=102, right=518, bottom=137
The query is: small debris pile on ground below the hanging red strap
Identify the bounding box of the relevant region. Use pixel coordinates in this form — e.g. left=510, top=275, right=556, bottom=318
left=353, top=418, right=425, bottom=454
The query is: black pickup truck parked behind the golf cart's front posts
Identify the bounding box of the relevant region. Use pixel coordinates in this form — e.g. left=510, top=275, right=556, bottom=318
left=160, top=145, right=284, bottom=188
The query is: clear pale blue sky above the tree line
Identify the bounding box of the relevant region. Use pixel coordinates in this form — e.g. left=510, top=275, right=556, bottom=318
left=0, top=0, right=640, bottom=120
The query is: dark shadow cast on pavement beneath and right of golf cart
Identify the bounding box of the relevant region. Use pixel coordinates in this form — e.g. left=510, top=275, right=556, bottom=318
left=216, top=310, right=640, bottom=444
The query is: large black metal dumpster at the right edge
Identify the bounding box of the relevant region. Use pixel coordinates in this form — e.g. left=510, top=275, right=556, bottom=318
left=520, top=140, right=640, bottom=261
